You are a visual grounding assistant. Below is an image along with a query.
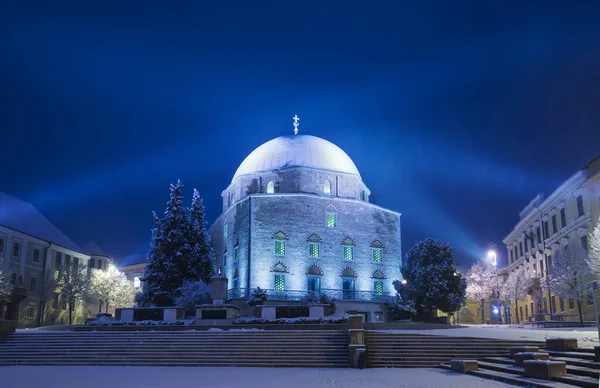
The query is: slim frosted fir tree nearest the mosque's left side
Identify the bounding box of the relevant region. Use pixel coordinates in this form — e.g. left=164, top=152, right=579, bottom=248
left=186, top=189, right=216, bottom=284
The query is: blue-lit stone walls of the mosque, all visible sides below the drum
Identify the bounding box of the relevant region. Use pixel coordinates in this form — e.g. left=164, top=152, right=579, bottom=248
left=210, top=194, right=402, bottom=293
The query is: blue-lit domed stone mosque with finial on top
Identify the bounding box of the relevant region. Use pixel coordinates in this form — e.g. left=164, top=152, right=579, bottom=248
left=209, top=116, right=401, bottom=321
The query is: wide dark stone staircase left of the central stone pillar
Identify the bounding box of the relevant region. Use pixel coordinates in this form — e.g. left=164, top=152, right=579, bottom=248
left=0, top=330, right=349, bottom=368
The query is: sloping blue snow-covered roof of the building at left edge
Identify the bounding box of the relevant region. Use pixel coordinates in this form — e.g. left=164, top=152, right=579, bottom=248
left=0, top=191, right=83, bottom=252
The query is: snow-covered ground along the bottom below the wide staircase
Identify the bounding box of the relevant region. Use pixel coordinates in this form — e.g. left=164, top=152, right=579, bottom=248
left=0, top=366, right=509, bottom=388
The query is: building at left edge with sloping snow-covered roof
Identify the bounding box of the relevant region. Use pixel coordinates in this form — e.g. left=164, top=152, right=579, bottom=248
left=0, top=192, right=110, bottom=327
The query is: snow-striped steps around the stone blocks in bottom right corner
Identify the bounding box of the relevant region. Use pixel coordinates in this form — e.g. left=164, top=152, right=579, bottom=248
left=462, top=348, right=600, bottom=388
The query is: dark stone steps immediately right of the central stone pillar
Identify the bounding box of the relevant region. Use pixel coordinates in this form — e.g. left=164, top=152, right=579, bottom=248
left=365, top=330, right=543, bottom=368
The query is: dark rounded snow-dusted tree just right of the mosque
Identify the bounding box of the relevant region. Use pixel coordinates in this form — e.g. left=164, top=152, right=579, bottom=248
left=394, top=238, right=466, bottom=318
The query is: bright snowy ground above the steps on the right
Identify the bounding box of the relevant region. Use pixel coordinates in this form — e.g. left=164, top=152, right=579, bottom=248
left=382, top=325, right=598, bottom=348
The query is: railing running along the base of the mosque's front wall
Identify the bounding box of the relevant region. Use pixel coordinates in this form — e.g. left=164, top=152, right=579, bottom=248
left=227, top=288, right=393, bottom=302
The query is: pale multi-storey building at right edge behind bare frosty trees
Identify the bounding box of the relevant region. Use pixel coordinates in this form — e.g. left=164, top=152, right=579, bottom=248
left=500, top=156, right=600, bottom=321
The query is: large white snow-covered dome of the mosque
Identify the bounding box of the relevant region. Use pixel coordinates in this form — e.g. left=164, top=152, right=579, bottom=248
left=231, top=135, right=360, bottom=182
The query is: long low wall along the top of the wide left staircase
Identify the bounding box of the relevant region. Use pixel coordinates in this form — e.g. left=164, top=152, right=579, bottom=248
left=72, top=323, right=348, bottom=331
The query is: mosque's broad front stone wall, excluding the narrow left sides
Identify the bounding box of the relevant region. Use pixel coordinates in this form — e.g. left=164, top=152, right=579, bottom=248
left=251, top=195, right=402, bottom=292
